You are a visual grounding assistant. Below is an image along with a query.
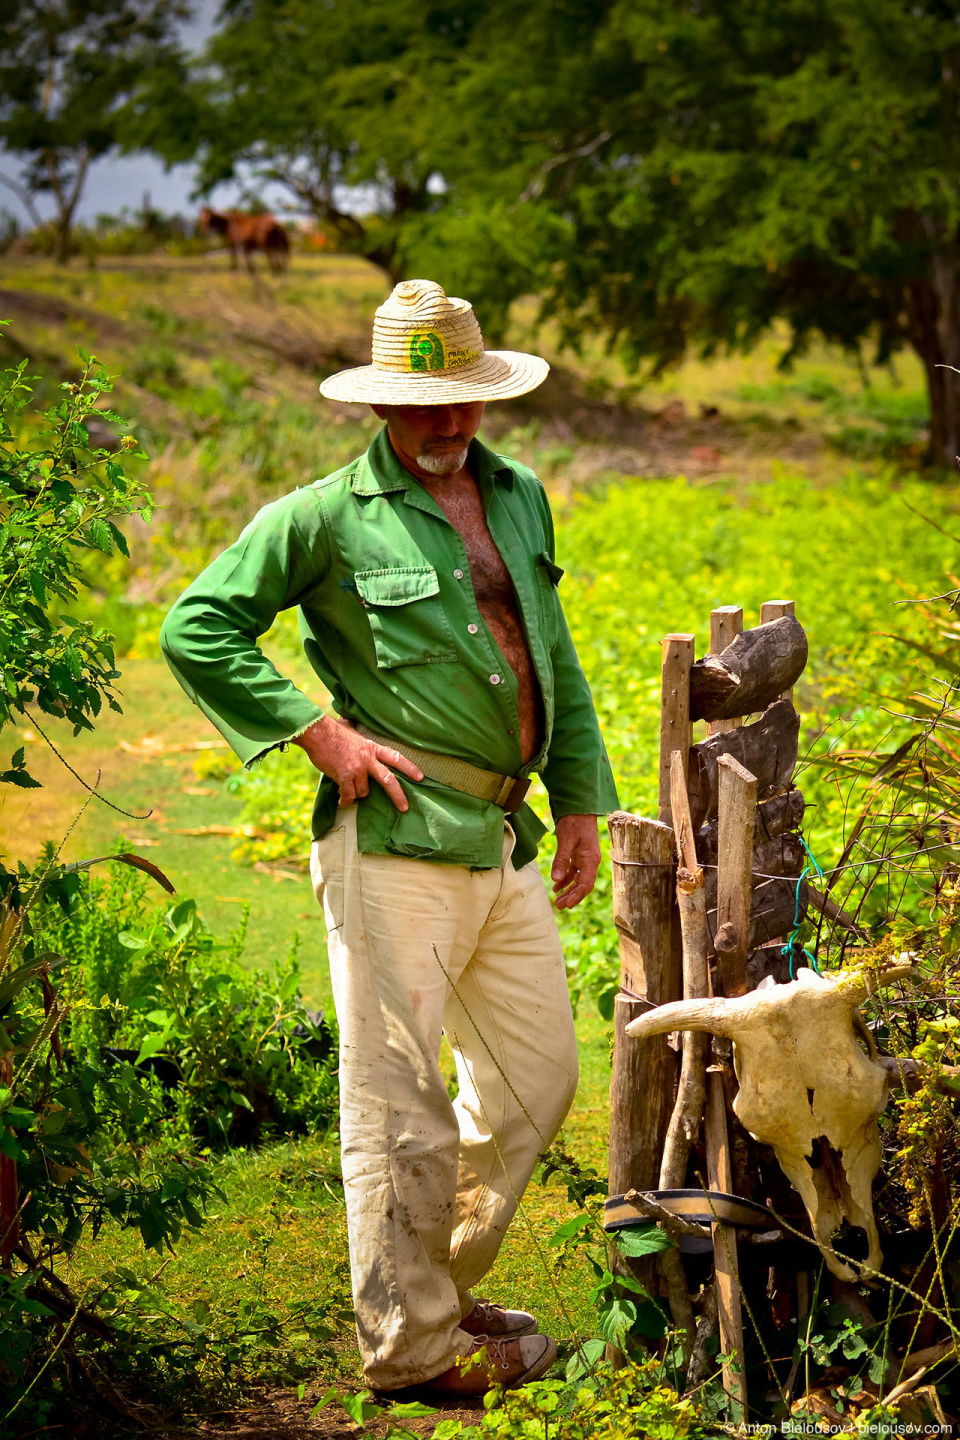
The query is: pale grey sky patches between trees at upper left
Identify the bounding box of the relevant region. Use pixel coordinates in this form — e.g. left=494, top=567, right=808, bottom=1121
left=0, top=0, right=270, bottom=225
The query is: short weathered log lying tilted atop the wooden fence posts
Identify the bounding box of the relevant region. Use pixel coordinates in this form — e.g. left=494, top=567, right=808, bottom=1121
left=689, top=615, right=807, bottom=720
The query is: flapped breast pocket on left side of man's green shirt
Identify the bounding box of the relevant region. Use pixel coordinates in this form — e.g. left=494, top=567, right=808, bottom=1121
left=354, top=564, right=458, bottom=670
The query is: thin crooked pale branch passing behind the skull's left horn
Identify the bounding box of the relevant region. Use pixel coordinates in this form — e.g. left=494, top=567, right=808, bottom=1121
left=659, top=750, right=710, bottom=1189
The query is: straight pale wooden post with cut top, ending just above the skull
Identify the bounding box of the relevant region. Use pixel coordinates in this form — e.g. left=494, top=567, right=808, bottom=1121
left=717, top=755, right=757, bottom=995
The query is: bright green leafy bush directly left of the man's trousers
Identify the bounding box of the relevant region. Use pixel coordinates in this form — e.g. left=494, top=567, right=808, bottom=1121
left=47, top=867, right=337, bottom=1148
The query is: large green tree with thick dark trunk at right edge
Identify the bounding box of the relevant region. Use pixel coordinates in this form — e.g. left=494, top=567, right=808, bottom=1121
left=443, top=0, right=960, bottom=467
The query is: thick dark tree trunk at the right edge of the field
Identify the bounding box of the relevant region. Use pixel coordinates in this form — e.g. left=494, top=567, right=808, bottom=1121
left=907, top=249, right=960, bottom=469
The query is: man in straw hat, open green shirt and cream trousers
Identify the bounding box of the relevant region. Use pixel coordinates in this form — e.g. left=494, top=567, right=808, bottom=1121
left=161, top=281, right=616, bottom=1397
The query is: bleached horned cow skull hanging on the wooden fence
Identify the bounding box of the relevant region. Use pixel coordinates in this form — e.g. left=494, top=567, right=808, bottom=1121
left=626, top=963, right=911, bottom=1280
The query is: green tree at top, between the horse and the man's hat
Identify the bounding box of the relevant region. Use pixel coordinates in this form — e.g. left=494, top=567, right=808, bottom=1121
left=150, top=0, right=482, bottom=281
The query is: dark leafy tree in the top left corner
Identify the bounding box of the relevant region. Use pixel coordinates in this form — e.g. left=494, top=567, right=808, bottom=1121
left=0, top=0, right=190, bottom=264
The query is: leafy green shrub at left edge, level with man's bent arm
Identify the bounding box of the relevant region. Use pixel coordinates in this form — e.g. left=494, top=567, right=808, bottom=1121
left=0, top=332, right=150, bottom=786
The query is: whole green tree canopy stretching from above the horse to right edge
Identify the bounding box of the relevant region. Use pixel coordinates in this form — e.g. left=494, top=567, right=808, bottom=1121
left=146, top=0, right=960, bottom=464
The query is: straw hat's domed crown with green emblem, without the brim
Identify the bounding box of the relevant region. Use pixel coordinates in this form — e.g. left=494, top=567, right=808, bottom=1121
left=373, top=279, right=484, bottom=377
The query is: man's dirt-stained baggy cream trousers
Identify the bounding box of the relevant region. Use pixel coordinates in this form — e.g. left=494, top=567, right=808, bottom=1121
left=311, top=808, right=577, bottom=1390
